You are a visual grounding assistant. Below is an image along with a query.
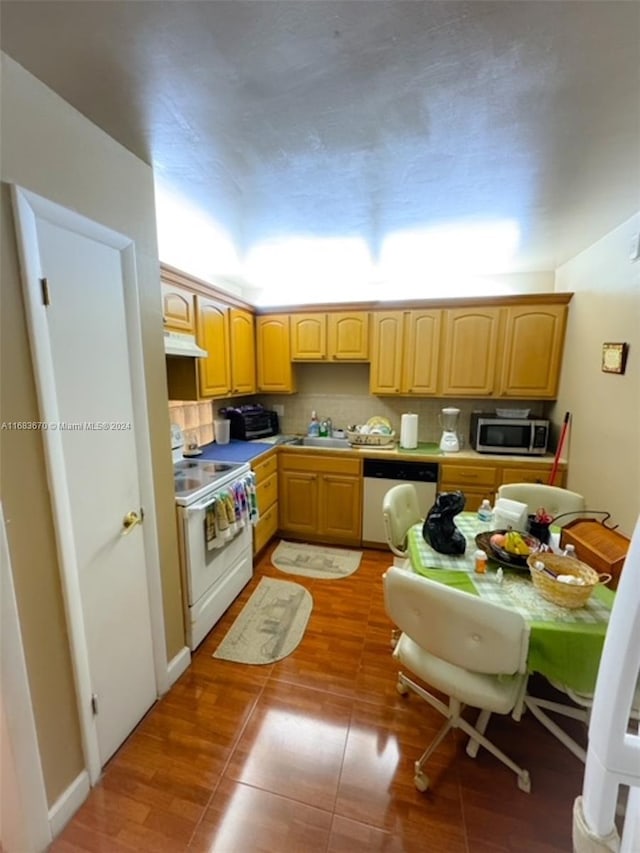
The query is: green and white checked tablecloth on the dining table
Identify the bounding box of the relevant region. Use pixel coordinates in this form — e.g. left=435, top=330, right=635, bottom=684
left=408, top=513, right=614, bottom=693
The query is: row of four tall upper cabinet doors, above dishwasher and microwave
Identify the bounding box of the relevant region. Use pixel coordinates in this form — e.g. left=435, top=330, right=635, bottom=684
left=370, top=301, right=567, bottom=399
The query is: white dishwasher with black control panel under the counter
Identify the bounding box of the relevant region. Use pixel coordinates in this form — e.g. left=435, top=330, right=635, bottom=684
left=362, top=459, right=438, bottom=545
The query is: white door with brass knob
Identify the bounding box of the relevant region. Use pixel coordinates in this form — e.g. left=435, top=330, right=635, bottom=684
left=11, top=188, right=156, bottom=778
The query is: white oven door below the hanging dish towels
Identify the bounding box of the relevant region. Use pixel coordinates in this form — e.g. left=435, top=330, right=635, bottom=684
left=178, top=499, right=252, bottom=607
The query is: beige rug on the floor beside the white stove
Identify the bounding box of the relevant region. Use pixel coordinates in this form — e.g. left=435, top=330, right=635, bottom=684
left=212, top=578, right=313, bottom=664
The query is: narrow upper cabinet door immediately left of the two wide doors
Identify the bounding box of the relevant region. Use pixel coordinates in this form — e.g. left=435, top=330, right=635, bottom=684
left=402, top=311, right=442, bottom=394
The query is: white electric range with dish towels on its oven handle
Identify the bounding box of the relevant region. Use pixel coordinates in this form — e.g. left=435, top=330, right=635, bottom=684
left=171, top=424, right=253, bottom=649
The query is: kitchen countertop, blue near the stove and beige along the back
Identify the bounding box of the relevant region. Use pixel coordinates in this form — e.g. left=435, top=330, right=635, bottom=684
left=188, top=439, right=566, bottom=469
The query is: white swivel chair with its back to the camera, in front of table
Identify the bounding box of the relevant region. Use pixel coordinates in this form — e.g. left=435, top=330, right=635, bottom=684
left=383, top=566, right=531, bottom=793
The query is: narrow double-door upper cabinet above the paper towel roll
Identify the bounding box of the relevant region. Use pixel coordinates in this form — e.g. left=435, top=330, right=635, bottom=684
left=369, top=309, right=442, bottom=395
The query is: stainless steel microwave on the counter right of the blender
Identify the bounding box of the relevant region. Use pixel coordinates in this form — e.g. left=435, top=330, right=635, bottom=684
left=469, top=412, right=549, bottom=456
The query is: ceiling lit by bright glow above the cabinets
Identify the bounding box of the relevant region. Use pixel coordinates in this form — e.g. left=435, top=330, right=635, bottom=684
left=0, top=0, right=640, bottom=296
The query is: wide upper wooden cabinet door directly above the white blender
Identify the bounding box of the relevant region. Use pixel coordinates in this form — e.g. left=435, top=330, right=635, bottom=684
left=440, top=307, right=500, bottom=397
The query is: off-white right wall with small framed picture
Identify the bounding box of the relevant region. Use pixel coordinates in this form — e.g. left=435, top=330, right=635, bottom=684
left=554, top=212, right=640, bottom=536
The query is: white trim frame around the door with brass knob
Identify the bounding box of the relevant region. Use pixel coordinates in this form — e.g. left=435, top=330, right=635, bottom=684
left=11, top=184, right=169, bottom=785
